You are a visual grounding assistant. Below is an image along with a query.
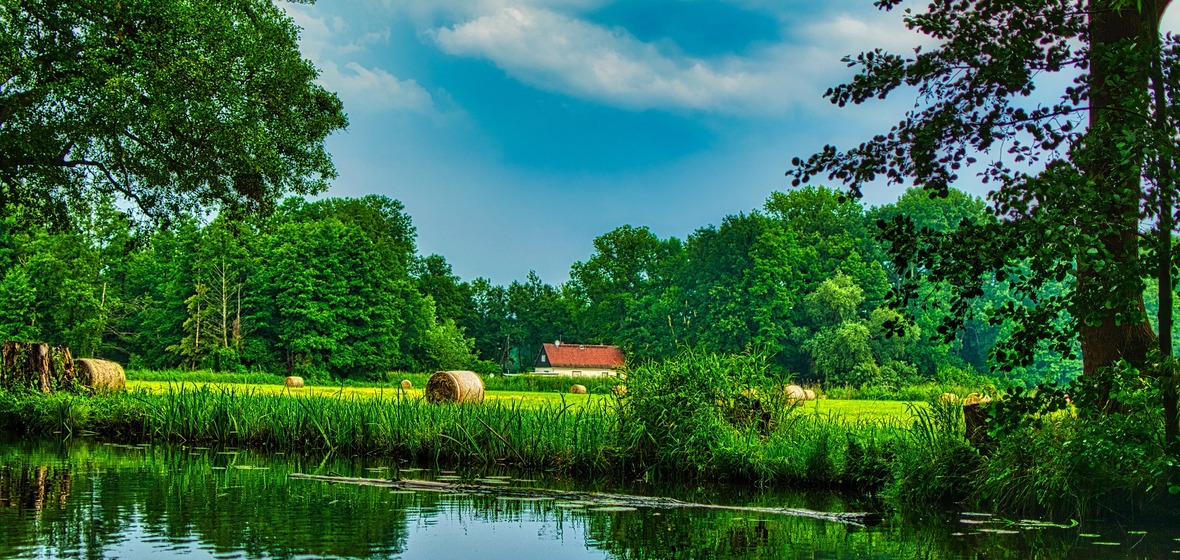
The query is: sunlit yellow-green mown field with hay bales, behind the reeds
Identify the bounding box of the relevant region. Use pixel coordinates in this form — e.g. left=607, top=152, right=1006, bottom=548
left=127, top=380, right=924, bottom=424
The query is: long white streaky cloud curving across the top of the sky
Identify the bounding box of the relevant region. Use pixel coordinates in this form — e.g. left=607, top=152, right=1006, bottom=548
left=432, top=2, right=915, bottom=114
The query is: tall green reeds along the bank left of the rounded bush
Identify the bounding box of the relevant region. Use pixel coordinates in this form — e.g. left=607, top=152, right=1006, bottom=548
left=0, top=384, right=618, bottom=470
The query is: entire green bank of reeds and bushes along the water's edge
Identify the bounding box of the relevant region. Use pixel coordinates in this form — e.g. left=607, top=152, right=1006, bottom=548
left=0, top=356, right=1175, bottom=519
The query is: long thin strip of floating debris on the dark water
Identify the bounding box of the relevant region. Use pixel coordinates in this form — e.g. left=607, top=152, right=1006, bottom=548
left=287, top=473, right=881, bottom=527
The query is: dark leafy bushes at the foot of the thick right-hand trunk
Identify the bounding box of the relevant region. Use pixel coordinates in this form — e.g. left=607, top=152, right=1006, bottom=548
left=978, top=362, right=1171, bottom=516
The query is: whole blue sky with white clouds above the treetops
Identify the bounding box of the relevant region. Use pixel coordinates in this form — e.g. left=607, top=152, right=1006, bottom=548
left=283, top=0, right=1174, bottom=284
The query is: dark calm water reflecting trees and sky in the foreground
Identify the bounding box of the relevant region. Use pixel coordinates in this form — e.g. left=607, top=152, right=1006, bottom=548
left=0, top=441, right=1180, bottom=560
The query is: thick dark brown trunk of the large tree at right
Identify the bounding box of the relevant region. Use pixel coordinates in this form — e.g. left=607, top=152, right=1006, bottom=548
left=1077, top=0, right=1168, bottom=409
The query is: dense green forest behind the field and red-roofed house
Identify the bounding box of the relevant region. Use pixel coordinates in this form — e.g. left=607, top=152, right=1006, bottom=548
left=0, top=187, right=1090, bottom=388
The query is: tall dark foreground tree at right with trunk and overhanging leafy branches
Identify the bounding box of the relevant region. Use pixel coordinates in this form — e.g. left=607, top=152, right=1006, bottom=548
left=788, top=0, right=1180, bottom=417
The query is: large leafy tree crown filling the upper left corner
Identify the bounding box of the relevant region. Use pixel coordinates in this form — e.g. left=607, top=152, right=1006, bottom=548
left=0, top=0, right=347, bottom=224
